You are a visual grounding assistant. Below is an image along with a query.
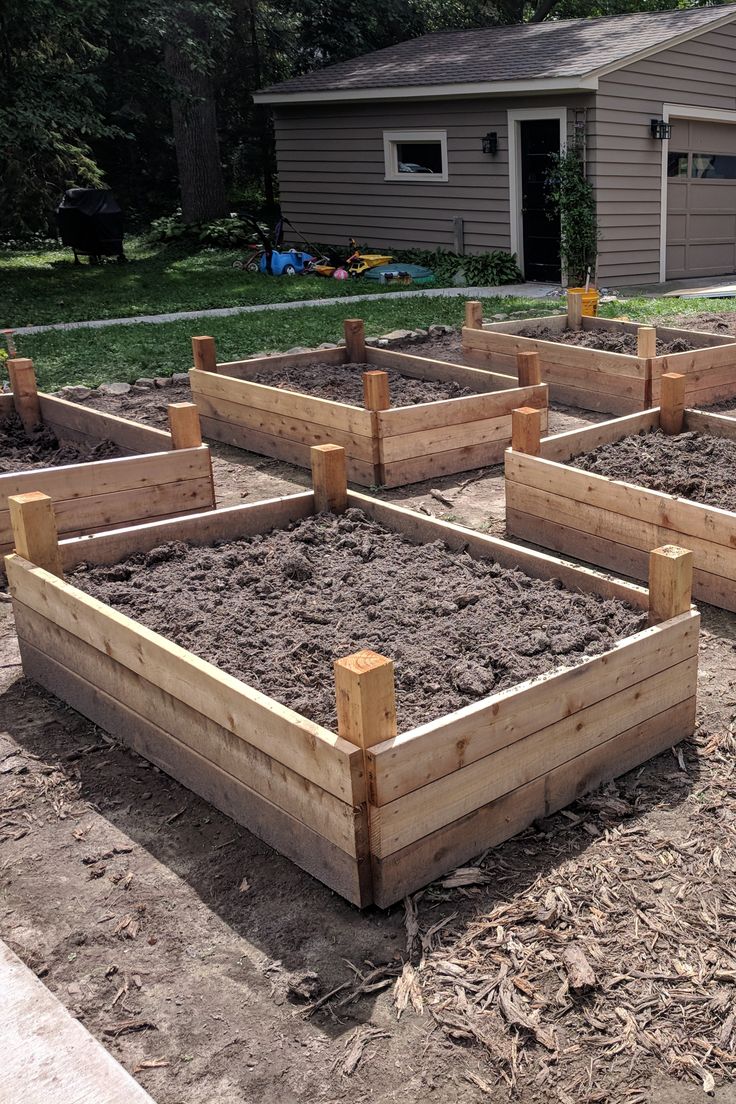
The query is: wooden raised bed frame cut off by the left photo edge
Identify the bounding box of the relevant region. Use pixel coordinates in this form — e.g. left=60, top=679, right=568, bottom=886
left=0, top=359, right=215, bottom=552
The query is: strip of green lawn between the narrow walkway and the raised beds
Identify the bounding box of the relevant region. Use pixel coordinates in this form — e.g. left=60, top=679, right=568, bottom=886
left=11, top=297, right=736, bottom=391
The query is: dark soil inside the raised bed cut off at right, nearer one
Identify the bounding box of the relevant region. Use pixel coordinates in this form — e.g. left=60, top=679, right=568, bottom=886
left=569, top=429, right=736, bottom=510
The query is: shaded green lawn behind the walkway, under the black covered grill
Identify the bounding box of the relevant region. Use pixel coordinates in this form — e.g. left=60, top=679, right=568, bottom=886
left=0, top=238, right=432, bottom=329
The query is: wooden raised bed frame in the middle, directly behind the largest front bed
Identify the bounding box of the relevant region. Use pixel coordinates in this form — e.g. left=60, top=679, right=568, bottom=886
left=190, top=320, right=547, bottom=487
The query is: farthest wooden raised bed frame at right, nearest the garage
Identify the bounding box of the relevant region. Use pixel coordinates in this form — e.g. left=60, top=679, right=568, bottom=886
left=462, top=295, right=736, bottom=414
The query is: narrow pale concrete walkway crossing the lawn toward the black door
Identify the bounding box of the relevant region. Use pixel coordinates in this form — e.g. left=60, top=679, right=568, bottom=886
left=13, top=284, right=559, bottom=335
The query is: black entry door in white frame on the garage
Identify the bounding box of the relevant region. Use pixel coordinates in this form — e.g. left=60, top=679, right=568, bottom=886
left=520, top=119, right=561, bottom=283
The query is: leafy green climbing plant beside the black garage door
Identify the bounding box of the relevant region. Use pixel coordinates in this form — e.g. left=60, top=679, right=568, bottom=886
left=546, top=147, right=598, bottom=287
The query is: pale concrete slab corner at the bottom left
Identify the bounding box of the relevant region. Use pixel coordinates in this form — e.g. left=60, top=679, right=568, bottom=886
left=0, top=942, right=154, bottom=1104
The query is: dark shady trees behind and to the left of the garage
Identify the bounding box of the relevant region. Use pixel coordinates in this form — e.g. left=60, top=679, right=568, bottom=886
left=0, top=0, right=726, bottom=238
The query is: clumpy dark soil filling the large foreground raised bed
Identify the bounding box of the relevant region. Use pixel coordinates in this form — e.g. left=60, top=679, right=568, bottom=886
left=73, top=509, right=646, bottom=730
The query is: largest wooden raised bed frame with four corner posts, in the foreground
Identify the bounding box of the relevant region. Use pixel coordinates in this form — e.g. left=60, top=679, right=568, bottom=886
left=7, top=445, right=700, bottom=907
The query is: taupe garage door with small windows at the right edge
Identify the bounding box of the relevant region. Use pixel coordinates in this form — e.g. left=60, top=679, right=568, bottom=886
left=666, top=119, right=736, bottom=279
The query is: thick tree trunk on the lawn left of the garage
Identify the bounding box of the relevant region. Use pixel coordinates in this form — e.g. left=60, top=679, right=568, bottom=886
left=163, top=13, right=227, bottom=223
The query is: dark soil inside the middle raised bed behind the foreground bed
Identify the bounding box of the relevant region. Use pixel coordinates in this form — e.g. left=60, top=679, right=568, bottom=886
left=252, top=364, right=476, bottom=406
